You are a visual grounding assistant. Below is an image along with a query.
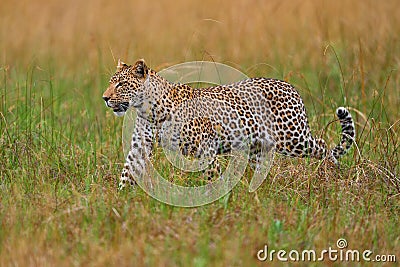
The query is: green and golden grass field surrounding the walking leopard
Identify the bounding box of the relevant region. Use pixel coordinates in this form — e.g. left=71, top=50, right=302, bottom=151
left=0, top=0, right=400, bottom=266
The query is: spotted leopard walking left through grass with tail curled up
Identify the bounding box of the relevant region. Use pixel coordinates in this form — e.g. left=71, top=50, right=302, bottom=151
left=102, top=59, right=356, bottom=189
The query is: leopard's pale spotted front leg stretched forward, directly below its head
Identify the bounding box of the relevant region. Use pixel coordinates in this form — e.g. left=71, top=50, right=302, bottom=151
left=118, top=117, right=153, bottom=190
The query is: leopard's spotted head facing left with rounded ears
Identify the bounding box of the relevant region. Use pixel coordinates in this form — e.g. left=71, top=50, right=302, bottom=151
left=103, top=59, right=149, bottom=116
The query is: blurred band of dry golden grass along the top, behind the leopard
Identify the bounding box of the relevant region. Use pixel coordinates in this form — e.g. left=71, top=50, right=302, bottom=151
left=0, top=0, right=400, bottom=69
